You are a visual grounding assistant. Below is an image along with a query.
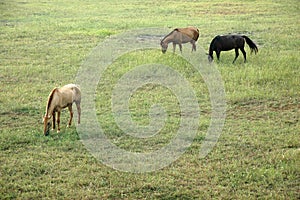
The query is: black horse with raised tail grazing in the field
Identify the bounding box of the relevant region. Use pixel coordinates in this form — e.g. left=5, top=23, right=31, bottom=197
left=208, top=35, right=258, bottom=63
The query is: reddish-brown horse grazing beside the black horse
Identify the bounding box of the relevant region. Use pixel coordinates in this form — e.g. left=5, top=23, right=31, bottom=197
left=160, top=26, right=199, bottom=53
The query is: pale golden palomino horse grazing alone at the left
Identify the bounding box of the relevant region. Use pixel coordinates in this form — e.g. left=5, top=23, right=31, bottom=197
left=43, top=84, right=81, bottom=135
